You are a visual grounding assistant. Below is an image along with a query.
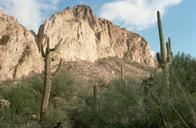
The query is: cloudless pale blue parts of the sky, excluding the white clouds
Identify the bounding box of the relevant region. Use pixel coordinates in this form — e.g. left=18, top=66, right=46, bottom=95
left=62, top=0, right=196, bottom=57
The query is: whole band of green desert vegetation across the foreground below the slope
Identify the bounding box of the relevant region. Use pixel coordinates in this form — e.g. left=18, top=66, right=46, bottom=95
left=0, top=53, right=196, bottom=128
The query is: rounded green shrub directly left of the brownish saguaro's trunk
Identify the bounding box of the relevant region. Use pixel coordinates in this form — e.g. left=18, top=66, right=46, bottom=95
left=3, top=76, right=42, bottom=115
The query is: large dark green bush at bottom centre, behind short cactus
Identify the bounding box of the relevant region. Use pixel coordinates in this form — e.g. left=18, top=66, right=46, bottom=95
left=73, top=80, right=144, bottom=128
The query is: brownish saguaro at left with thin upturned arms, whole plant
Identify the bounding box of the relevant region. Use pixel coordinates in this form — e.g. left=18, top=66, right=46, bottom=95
left=40, top=37, right=62, bottom=121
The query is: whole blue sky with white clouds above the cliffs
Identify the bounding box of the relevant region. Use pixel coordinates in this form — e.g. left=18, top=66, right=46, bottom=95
left=0, top=0, right=196, bottom=57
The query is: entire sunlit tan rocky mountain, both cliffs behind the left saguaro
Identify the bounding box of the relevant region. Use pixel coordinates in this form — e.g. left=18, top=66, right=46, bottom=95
left=0, top=5, right=155, bottom=81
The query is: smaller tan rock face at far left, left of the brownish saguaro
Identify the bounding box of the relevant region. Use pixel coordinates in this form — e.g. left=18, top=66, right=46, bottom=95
left=0, top=12, right=43, bottom=81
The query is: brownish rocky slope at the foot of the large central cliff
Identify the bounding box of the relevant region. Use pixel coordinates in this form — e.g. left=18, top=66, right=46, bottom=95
left=61, top=57, right=155, bottom=84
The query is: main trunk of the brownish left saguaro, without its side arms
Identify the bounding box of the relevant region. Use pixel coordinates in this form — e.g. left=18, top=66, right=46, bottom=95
left=40, top=41, right=52, bottom=121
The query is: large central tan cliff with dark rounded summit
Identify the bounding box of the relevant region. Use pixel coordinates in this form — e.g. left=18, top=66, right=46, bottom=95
left=38, top=5, right=154, bottom=66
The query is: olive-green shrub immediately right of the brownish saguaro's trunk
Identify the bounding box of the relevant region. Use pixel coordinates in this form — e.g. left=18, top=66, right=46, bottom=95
left=51, top=72, right=88, bottom=107
